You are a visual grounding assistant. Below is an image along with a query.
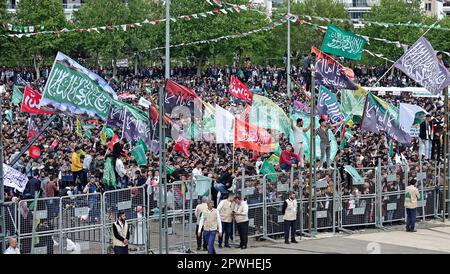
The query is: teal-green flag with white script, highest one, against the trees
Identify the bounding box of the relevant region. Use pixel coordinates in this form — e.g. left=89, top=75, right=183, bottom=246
left=322, top=24, right=367, bottom=60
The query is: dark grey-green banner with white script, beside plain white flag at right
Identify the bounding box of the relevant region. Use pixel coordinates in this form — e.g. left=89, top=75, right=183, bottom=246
left=361, top=93, right=411, bottom=144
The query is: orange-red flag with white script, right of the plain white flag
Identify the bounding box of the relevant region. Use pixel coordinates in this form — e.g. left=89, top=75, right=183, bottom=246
left=234, top=118, right=272, bottom=153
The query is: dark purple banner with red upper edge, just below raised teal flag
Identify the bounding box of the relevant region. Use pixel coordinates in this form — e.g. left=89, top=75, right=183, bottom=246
left=311, top=47, right=358, bottom=90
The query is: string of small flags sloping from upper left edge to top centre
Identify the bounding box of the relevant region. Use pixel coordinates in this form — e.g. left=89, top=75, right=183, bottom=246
left=1, top=5, right=253, bottom=38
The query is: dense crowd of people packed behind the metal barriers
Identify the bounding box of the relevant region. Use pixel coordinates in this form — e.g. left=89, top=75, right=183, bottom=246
left=0, top=55, right=444, bottom=252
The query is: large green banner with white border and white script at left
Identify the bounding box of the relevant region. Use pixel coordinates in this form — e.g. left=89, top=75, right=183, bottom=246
left=40, top=52, right=117, bottom=120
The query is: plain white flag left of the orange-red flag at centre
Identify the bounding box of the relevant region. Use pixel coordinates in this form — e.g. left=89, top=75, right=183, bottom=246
left=216, top=105, right=234, bottom=144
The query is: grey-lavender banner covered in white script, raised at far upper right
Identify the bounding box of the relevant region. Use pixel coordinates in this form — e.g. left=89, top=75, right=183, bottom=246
left=394, top=36, right=450, bottom=94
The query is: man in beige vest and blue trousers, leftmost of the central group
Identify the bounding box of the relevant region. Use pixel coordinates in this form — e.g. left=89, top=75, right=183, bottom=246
left=197, top=200, right=222, bottom=254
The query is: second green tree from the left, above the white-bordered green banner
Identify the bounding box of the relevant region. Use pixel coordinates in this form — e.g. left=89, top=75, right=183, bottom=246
left=74, top=0, right=130, bottom=77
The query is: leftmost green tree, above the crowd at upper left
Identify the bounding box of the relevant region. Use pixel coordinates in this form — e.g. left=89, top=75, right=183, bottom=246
left=17, top=0, right=67, bottom=79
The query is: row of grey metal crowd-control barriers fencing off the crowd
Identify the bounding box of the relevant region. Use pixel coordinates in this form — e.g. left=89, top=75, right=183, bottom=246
left=0, top=165, right=448, bottom=254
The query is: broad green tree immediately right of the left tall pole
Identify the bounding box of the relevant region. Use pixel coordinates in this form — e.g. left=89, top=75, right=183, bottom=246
left=171, top=0, right=268, bottom=74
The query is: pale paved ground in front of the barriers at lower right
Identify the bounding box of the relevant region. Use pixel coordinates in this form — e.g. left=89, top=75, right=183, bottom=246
left=189, top=221, right=450, bottom=254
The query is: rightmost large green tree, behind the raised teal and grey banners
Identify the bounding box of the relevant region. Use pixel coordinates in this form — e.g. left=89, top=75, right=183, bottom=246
left=357, top=0, right=428, bottom=65
